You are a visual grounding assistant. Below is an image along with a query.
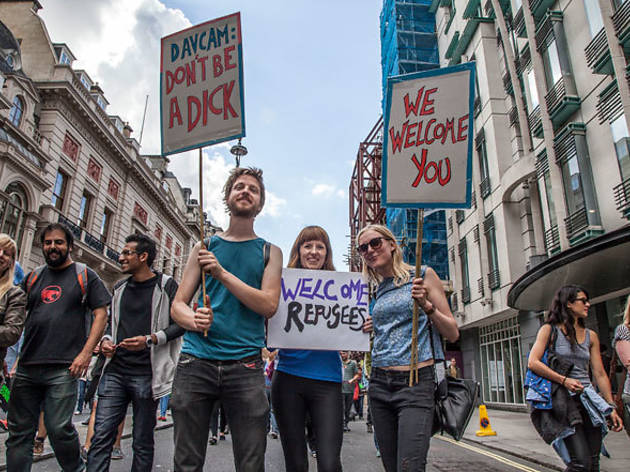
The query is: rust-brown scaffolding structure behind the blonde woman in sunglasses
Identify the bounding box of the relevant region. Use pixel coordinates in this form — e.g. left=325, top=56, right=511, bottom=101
left=346, top=117, right=385, bottom=271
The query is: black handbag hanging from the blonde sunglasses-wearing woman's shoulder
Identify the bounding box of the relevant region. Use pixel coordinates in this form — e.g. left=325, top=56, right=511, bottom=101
left=427, top=320, right=480, bottom=441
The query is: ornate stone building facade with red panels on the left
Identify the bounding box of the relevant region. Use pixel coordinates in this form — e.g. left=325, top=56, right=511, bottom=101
left=0, top=1, right=205, bottom=287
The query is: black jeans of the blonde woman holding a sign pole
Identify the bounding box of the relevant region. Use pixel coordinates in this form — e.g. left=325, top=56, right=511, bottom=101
left=368, top=366, right=435, bottom=472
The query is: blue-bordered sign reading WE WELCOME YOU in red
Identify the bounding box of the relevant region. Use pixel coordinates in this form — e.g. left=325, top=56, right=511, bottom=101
left=381, top=63, right=475, bottom=208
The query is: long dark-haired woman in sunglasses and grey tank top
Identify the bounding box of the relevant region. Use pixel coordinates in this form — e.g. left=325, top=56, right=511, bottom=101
left=527, top=285, right=623, bottom=472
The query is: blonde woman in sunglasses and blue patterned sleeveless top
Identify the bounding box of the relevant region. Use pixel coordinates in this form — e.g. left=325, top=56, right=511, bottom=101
left=358, top=225, right=459, bottom=472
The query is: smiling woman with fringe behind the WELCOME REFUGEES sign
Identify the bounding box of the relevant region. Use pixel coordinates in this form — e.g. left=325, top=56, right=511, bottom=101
left=271, top=226, right=343, bottom=472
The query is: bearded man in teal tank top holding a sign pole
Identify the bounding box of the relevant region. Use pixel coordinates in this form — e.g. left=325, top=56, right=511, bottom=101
left=171, top=168, right=282, bottom=472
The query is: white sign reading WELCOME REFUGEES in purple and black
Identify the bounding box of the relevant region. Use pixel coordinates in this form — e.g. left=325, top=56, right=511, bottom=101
left=267, top=269, right=370, bottom=351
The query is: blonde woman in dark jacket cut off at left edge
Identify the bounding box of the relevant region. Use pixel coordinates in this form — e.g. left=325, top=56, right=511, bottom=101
left=0, top=233, right=26, bottom=378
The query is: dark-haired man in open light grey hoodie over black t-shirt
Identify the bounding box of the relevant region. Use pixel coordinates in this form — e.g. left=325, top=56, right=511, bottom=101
left=87, top=234, right=184, bottom=472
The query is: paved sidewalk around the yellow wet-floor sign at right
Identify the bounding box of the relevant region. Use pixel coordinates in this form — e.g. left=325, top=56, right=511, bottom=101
left=464, top=409, right=630, bottom=472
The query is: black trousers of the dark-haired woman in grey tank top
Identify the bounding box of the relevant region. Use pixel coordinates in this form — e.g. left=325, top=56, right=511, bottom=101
left=564, top=395, right=602, bottom=472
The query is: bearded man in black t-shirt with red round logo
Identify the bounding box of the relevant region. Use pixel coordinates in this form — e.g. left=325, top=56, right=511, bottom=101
left=6, top=223, right=111, bottom=471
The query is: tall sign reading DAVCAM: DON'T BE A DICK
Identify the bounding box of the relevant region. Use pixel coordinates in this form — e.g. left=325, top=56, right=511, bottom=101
left=160, top=13, right=245, bottom=155
